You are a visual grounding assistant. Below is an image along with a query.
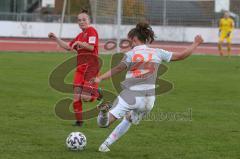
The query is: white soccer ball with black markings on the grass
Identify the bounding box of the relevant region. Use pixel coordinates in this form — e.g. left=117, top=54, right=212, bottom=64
left=66, top=132, right=87, bottom=151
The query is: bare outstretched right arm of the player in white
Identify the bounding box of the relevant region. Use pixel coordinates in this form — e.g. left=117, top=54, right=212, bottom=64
left=171, top=35, right=203, bottom=61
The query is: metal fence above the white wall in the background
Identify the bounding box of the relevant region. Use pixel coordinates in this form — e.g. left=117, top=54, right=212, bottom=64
left=0, top=0, right=240, bottom=27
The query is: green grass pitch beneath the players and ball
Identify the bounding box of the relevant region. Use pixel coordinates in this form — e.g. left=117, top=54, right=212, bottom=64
left=0, top=52, right=240, bottom=159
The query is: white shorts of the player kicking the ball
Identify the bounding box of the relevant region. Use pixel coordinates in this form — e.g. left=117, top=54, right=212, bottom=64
left=110, top=95, right=155, bottom=124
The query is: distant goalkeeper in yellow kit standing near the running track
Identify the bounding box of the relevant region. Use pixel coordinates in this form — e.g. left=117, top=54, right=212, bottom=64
left=218, top=12, right=234, bottom=56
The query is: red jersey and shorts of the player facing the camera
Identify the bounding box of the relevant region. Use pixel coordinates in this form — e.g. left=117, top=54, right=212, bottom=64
left=69, top=27, right=99, bottom=80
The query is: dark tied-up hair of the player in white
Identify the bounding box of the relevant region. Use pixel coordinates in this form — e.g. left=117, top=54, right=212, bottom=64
left=128, top=22, right=155, bottom=44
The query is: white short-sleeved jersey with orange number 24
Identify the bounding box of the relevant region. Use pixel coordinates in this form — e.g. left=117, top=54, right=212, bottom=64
left=122, top=45, right=172, bottom=93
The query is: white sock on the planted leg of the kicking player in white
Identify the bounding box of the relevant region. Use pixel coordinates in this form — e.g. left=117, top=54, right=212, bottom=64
left=103, top=118, right=131, bottom=147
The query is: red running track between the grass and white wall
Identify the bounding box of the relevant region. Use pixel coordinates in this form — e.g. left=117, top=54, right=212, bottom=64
left=0, top=38, right=240, bottom=55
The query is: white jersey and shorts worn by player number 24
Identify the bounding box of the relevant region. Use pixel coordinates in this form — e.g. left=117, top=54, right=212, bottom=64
left=110, top=45, right=172, bottom=124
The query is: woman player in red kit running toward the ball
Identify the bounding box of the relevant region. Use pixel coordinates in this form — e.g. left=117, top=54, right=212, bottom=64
left=48, top=10, right=100, bottom=126
